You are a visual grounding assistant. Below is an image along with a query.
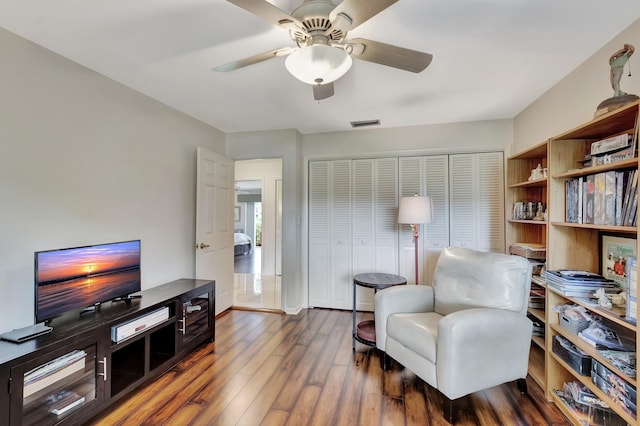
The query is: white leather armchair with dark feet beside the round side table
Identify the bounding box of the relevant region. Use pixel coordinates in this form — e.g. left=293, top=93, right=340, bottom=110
left=374, top=247, right=532, bottom=423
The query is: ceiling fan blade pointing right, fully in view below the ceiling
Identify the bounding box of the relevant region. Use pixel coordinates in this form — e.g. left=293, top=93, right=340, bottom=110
left=349, top=38, right=433, bottom=73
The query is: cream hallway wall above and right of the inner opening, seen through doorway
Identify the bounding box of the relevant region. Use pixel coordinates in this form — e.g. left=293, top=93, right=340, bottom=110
left=235, top=158, right=282, bottom=275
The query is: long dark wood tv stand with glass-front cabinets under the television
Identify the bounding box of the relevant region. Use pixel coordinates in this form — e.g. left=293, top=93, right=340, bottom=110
left=0, top=279, right=215, bottom=426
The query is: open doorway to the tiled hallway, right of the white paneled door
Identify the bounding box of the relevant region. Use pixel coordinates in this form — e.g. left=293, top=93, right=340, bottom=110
left=233, top=159, right=282, bottom=311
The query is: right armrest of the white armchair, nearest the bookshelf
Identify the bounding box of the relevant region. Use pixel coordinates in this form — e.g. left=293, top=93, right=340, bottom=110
left=436, top=308, right=533, bottom=399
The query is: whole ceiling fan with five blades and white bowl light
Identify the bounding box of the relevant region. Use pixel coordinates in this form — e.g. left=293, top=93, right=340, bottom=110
left=213, top=0, right=433, bottom=100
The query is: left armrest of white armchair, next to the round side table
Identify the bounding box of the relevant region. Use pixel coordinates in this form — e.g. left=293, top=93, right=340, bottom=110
left=373, top=285, right=434, bottom=351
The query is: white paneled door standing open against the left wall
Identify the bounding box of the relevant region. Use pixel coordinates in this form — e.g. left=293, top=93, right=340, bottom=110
left=195, top=147, right=234, bottom=315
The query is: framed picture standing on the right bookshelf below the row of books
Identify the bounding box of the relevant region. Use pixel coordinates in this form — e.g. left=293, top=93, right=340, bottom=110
left=600, top=234, right=637, bottom=289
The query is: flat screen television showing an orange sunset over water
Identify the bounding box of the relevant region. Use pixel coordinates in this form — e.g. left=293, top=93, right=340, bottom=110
left=35, top=240, right=141, bottom=323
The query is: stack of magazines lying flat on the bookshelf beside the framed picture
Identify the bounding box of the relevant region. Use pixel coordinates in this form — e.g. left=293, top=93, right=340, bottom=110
left=544, top=269, right=620, bottom=297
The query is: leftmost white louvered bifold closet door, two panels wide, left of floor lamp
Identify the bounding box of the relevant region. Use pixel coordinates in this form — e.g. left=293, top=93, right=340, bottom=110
left=309, top=160, right=353, bottom=309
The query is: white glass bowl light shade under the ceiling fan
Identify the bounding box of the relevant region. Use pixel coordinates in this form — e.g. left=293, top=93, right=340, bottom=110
left=284, top=44, right=353, bottom=84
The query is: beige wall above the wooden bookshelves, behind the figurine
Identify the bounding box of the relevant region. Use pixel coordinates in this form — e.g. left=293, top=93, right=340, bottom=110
left=513, top=19, right=640, bottom=153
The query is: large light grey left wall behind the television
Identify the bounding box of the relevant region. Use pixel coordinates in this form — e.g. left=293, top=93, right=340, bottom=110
left=0, top=29, right=225, bottom=332
